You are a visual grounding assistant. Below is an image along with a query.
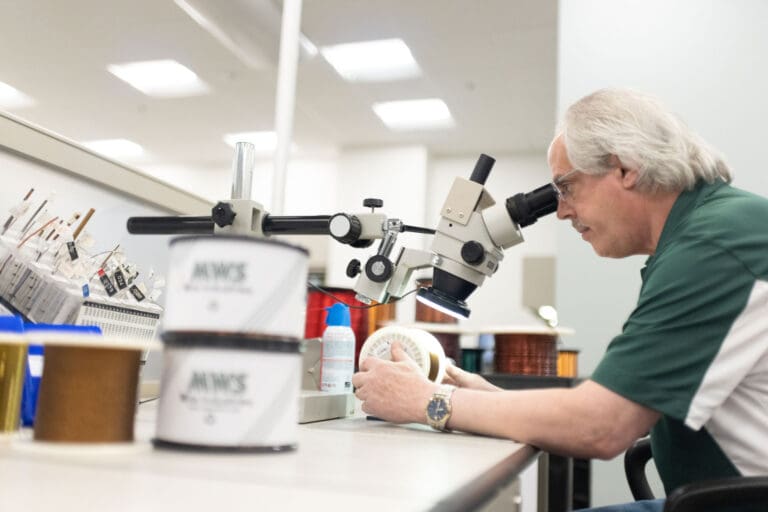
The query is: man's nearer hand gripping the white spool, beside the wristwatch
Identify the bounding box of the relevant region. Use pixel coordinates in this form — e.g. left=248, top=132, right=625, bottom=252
left=352, top=341, right=436, bottom=423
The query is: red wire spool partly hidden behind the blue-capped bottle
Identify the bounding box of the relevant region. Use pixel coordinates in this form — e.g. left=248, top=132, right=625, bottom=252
left=304, top=288, right=368, bottom=368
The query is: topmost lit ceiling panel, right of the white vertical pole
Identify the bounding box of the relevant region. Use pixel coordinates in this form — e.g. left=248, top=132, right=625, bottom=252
left=320, top=39, right=421, bottom=82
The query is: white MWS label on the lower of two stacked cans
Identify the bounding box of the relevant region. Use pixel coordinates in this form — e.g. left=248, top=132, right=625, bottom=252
left=157, top=347, right=301, bottom=448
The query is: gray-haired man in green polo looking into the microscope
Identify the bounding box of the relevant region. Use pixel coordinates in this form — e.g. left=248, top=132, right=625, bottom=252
left=352, top=89, right=768, bottom=510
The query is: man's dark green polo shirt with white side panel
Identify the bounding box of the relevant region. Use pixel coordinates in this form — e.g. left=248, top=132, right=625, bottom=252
left=592, top=180, right=768, bottom=493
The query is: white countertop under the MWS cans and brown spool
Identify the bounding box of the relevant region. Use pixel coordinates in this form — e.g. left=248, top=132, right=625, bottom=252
left=0, top=402, right=537, bottom=512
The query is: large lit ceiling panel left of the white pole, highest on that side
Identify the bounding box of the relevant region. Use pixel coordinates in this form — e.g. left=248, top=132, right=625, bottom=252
left=107, top=59, right=210, bottom=98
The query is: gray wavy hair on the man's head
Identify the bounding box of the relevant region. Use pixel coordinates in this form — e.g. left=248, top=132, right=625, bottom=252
left=558, top=89, right=732, bottom=191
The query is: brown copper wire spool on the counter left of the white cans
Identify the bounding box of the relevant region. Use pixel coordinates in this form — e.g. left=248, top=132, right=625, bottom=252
left=34, top=343, right=150, bottom=443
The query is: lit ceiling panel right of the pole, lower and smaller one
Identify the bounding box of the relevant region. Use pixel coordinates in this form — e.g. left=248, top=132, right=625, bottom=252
left=373, top=98, right=455, bottom=131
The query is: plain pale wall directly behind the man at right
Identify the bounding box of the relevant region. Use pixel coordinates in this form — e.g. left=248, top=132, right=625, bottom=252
left=557, top=0, right=768, bottom=505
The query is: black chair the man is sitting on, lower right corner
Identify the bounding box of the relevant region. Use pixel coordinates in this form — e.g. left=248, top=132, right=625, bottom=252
left=624, top=437, right=768, bottom=512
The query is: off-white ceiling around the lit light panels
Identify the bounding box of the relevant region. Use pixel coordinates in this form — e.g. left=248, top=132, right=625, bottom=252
left=0, top=0, right=557, bottom=171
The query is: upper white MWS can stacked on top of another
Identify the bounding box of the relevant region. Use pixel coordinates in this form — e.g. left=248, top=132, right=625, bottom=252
left=163, top=235, right=308, bottom=339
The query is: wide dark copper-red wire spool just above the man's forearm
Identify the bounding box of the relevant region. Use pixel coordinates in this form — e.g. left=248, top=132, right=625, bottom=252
left=494, top=333, right=557, bottom=376
